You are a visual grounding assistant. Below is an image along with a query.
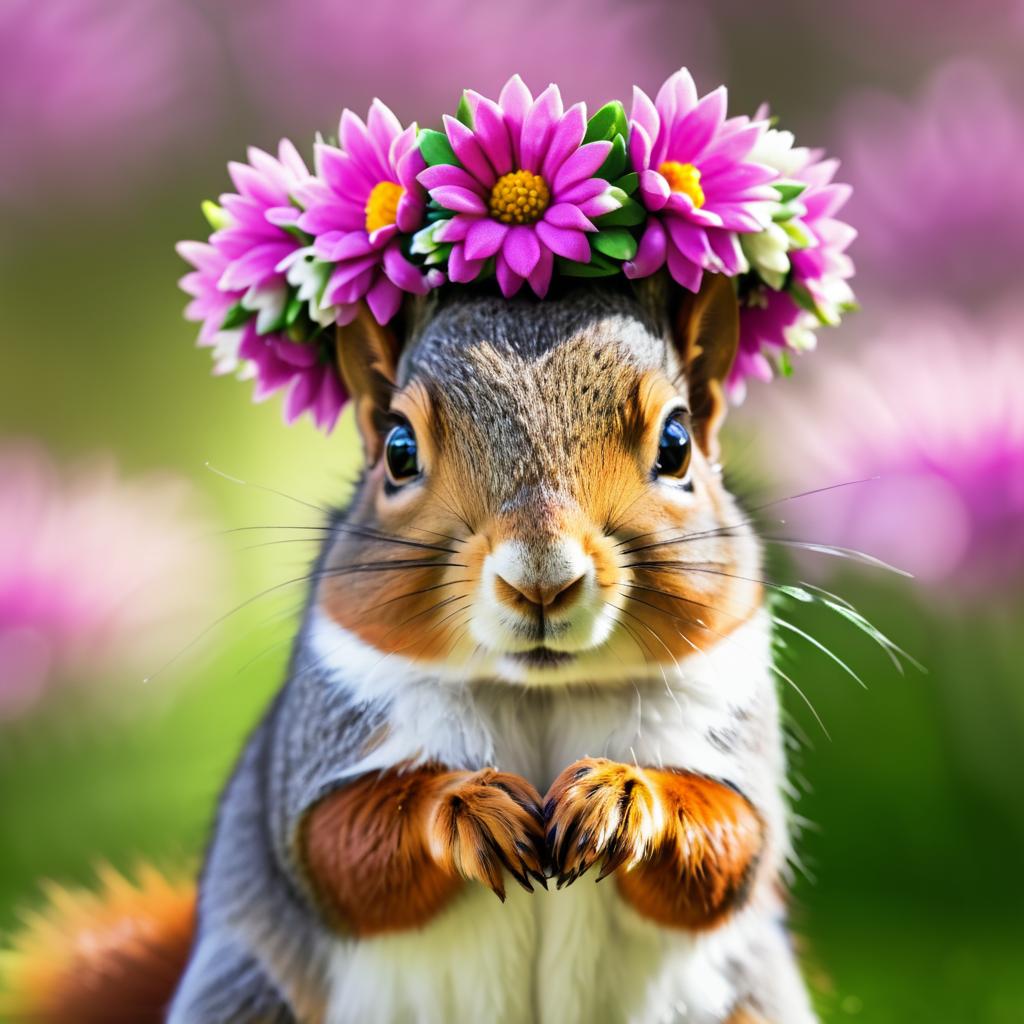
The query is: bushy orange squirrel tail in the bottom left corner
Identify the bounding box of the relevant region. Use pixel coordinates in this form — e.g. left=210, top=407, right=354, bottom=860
left=0, top=866, right=196, bottom=1024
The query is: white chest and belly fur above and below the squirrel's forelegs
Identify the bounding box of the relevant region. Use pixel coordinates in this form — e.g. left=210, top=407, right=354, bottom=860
left=313, top=615, right=790, bottom=1024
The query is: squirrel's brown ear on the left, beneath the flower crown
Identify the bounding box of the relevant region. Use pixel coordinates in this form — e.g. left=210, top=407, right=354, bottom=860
left=335, top=302, right=400, bottom=464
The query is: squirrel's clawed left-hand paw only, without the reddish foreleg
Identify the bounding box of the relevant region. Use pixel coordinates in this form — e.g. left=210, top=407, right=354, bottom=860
left=430, top=768, right=547, bottom=902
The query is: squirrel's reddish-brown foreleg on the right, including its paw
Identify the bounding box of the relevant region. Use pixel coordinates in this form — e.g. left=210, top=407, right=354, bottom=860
left=545, top=759, right=764, bottom=930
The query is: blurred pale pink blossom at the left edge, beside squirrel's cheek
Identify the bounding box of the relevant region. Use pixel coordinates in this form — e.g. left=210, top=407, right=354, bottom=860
left=0, top=442, right=223, bottom=720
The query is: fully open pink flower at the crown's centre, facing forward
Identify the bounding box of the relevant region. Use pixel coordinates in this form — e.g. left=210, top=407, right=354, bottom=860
left=419, top=75, right=618, bottom=297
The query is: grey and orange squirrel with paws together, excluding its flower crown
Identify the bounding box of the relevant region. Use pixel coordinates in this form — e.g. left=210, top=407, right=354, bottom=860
left=0, top=274, right=816, bottom=1024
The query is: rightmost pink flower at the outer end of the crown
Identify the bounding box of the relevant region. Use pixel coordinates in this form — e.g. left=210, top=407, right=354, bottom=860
left=727, top=151, right=857, bottom=401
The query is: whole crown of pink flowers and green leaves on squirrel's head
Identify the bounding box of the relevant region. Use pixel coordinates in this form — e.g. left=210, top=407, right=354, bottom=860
left=178, top=69, right=856, bottom=431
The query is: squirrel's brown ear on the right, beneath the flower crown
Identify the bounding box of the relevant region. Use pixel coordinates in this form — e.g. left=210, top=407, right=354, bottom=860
left=673, top=273, right=739, bottom=460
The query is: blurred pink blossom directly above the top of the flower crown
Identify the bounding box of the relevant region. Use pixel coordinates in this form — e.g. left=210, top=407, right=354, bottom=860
left=222, top=0, right=718, bottom=131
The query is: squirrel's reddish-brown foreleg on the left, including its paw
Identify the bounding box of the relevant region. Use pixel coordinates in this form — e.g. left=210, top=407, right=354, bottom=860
left=301, top=766, right=544, bottom=936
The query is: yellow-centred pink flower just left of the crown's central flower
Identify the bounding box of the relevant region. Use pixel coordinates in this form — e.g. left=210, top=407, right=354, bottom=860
left=295, top=99, right=439, bottom=324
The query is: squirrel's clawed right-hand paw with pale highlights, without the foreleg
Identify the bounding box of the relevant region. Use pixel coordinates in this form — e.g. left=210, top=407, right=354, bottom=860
left=544, top=758, right=662, bottom=889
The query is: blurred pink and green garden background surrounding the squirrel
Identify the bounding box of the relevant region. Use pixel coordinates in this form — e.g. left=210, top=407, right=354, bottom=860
left=0, top=0, right=1024, bottom=1024
